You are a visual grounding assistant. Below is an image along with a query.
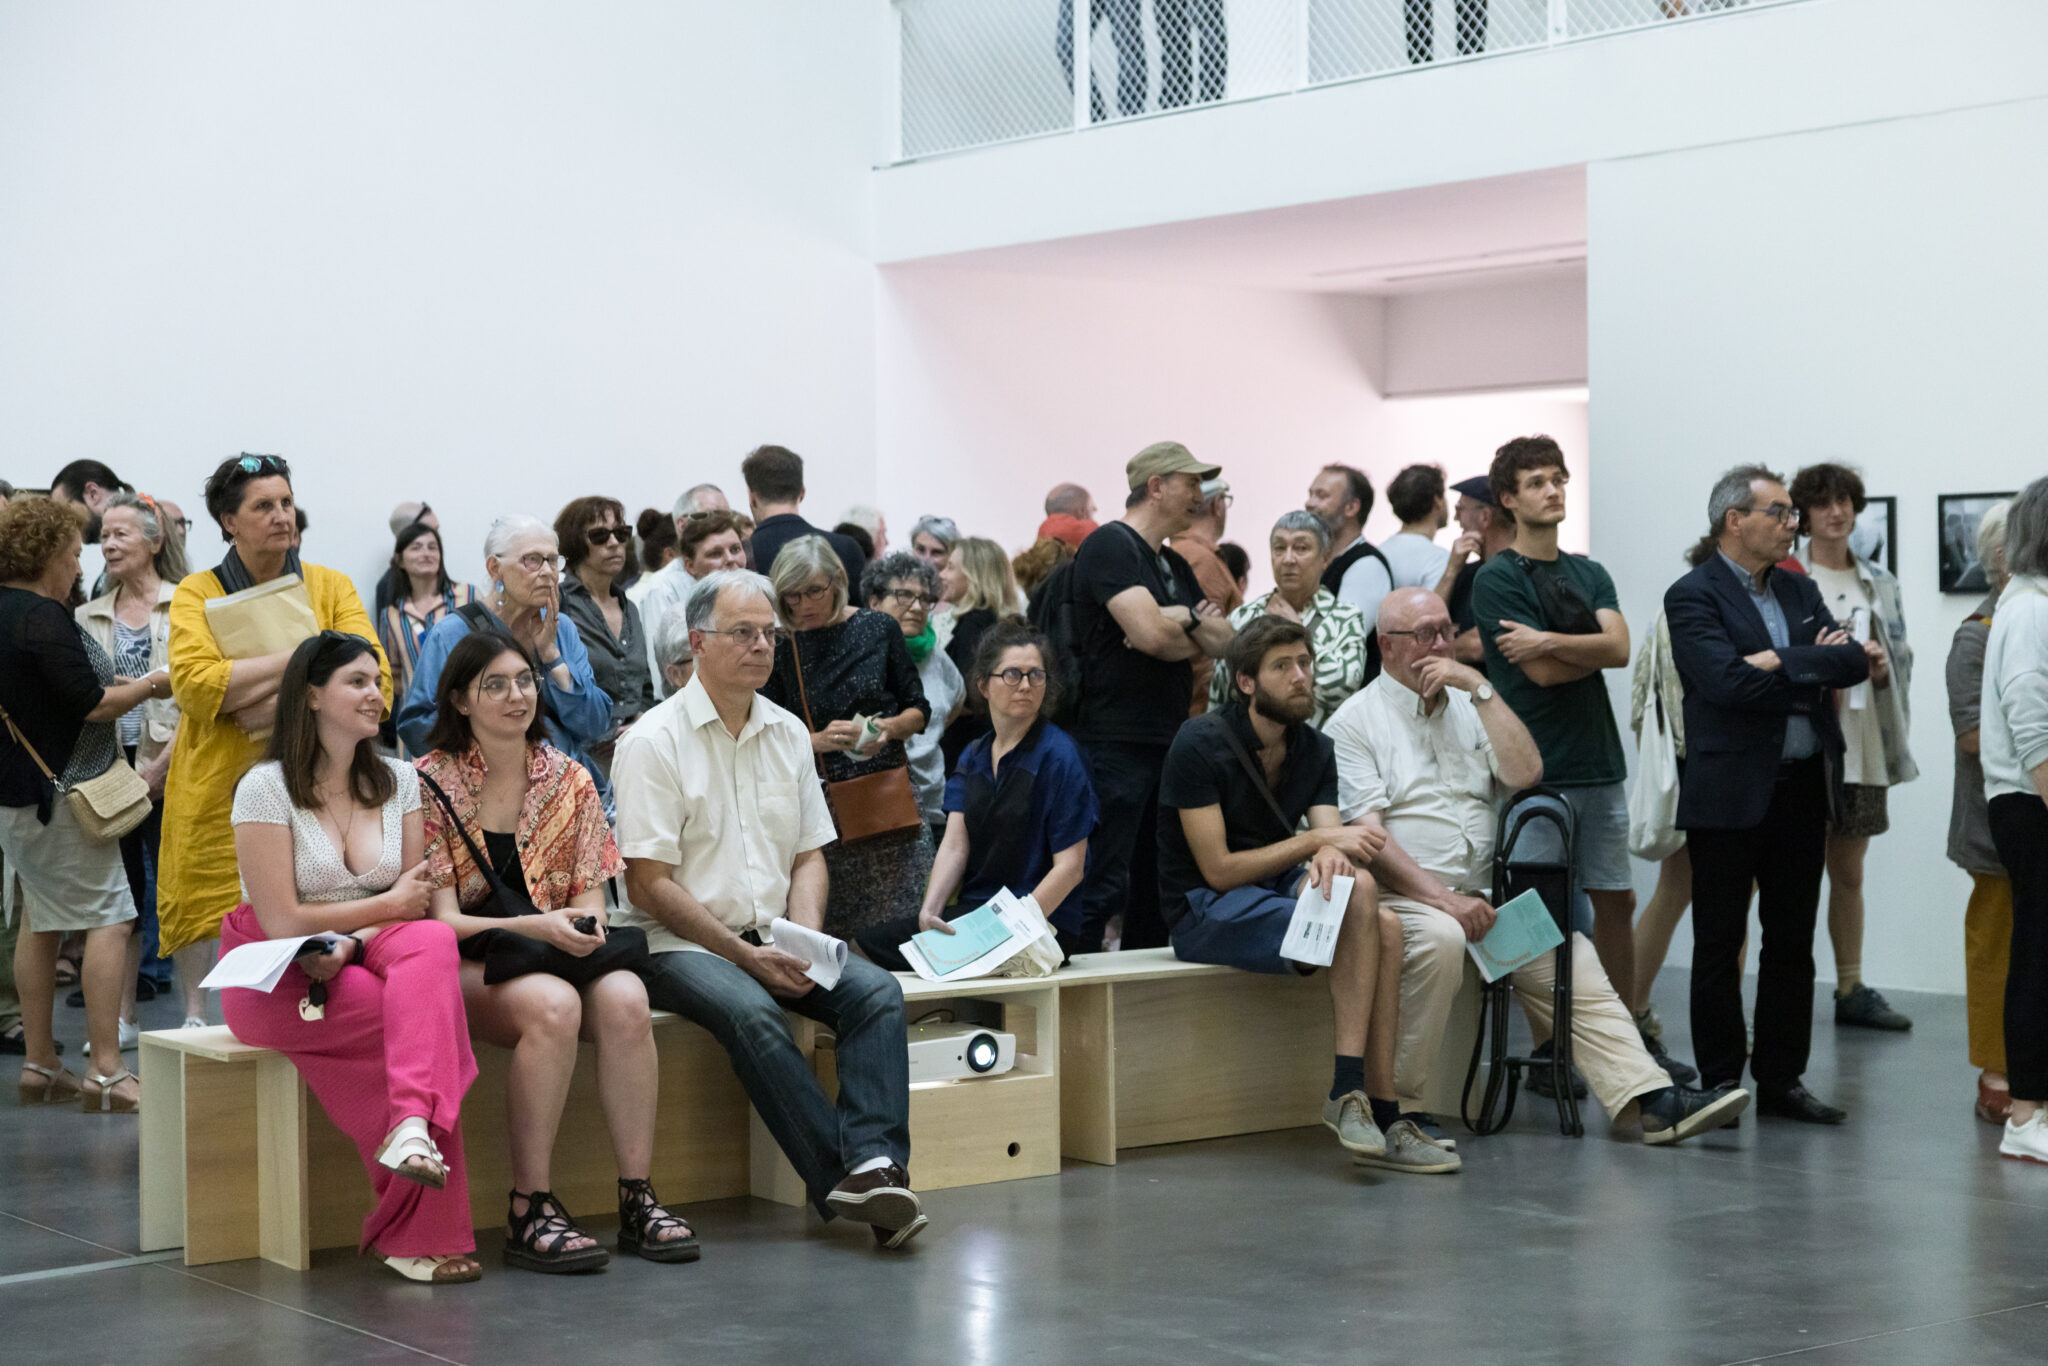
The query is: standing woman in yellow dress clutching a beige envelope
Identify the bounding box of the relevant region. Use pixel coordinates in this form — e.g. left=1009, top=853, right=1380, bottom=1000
left=156, top=455, right=391, bottom=1024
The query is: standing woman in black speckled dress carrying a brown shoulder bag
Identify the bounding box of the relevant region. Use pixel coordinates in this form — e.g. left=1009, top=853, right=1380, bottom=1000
left=762, top=537, right=932, bottom=936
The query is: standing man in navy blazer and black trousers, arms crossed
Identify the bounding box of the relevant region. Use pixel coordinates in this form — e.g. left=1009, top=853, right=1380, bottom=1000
left=1665, top=465, right=1886, bottom=1124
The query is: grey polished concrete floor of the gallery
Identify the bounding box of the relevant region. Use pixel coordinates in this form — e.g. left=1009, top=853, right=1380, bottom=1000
left=0, top=973, right=2048, bottom=1366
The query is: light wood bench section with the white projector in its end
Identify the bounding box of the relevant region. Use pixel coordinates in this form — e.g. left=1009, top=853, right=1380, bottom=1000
left=137, top=975, right=1061, bottom=1270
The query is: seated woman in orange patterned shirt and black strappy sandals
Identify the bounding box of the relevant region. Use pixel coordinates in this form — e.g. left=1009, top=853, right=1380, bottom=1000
left=420, top=631, right=698, bottom=1274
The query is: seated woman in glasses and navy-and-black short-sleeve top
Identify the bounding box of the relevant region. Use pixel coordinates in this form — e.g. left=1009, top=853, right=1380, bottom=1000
left=860, top=618, right=1098, bottom=973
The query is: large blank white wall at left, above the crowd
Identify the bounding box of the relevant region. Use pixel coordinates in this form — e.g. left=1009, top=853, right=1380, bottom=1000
left=0, top=0, right=887, bottom=596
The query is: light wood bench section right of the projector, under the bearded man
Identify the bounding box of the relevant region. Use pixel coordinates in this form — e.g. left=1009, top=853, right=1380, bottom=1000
left=1057, top=948, right=1479, bottom=1163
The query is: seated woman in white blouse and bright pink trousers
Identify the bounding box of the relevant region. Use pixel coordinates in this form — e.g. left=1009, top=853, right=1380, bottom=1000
left=221, top=631, right=481, bottom=1284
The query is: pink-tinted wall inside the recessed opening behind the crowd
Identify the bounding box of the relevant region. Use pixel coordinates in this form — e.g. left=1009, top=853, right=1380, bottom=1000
left=877, top=266, right=1587, bottom=592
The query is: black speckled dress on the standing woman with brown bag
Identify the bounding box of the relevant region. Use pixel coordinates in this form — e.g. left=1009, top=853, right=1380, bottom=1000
left=762, top=608, right=934, bottom=938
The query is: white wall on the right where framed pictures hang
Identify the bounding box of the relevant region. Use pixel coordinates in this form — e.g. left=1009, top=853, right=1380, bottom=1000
left=1589, top=100, right=2048, bottom=991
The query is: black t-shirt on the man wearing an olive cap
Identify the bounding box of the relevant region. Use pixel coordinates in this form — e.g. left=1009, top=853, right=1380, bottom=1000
left=1073, top=522, right=1202, bottom=745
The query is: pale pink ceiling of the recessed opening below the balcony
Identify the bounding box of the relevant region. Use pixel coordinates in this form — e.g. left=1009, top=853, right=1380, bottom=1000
left=893, top=166, right=1585, bottom=295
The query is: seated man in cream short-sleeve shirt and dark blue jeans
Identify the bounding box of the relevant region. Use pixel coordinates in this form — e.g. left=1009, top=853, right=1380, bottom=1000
left=612, top=569, right=926, bottom=1247
